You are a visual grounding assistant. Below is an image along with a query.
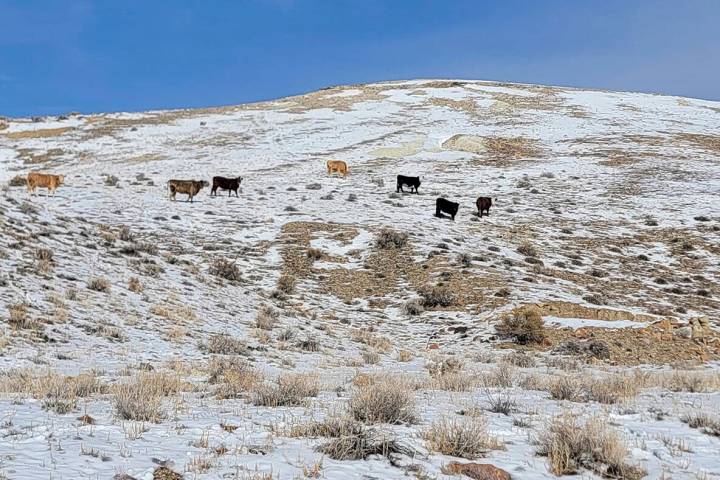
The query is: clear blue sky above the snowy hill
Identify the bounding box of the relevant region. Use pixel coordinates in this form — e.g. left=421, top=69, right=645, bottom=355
left=0, top=0, right=720, bottom=116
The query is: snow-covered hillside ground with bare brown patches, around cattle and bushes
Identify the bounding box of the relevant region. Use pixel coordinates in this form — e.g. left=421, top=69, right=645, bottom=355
left=0, top=80, right=720, bottom=479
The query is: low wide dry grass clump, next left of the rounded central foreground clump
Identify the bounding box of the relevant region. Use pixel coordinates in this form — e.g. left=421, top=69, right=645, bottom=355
left=253, top=373, right=320, bottom=407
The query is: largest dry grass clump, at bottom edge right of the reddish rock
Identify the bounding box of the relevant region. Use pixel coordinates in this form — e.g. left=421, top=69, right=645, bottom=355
left=536, top=413, right=646, bottom=480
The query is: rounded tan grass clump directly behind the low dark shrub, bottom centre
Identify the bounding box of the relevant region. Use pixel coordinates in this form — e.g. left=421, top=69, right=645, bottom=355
left=348, top=376, right=417, bottom=424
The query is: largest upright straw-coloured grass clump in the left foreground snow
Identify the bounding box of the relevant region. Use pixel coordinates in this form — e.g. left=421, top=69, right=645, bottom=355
left=113, top=372, right=187, bottom=422
